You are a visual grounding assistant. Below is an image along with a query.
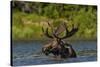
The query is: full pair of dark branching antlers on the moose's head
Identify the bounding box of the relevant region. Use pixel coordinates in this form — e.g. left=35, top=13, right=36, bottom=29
left=42, top=22, right=78, bottom=39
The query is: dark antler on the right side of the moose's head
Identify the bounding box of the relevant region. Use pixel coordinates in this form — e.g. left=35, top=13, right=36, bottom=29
left=54, top=23, right=78, bottom=39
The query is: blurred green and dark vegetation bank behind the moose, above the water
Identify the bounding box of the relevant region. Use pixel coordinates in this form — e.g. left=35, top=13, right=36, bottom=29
left=11, top=1, right=97, bottom=40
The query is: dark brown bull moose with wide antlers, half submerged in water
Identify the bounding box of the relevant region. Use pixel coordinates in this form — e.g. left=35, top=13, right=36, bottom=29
left=42, top=22, right=78, bottom=58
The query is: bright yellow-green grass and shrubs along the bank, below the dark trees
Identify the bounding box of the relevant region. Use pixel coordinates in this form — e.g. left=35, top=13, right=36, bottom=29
left=12, top=10, right=97, bottom=40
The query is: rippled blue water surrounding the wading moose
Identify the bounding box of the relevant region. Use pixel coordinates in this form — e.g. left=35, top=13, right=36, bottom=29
left=12, top=41, right=97, bottom=66
